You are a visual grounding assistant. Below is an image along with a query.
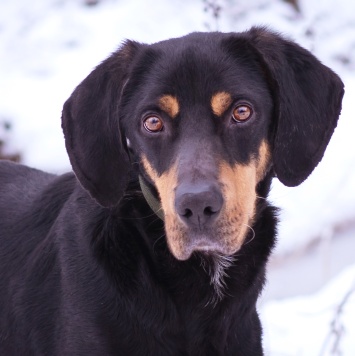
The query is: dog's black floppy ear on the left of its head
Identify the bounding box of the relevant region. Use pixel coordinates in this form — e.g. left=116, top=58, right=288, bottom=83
left=62, top=42, right=139, bottom=207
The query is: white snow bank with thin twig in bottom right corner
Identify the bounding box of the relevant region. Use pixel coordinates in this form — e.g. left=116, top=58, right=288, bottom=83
left=261, top=265, right=355, bottom=356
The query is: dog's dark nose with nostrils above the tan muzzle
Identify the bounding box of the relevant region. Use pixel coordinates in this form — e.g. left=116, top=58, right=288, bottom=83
left=175, top=184, right=223, bottom=229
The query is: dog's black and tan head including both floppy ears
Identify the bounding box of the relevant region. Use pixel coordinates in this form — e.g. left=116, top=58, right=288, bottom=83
left=63, top=28, right=343, bottom=260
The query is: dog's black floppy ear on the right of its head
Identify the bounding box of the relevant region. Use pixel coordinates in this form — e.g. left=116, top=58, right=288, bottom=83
left=248, top=28, right=344, bottom=187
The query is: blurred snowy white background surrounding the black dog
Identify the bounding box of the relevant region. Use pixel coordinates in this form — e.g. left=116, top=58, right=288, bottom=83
left=0, top=0, right=355, bottom=356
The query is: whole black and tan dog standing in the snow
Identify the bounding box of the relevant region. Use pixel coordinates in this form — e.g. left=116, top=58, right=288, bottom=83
left=0, top=28, right=343, bottom=356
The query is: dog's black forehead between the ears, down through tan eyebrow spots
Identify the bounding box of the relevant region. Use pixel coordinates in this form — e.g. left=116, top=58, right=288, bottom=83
left=134, top=33, right=267, bottom=108
